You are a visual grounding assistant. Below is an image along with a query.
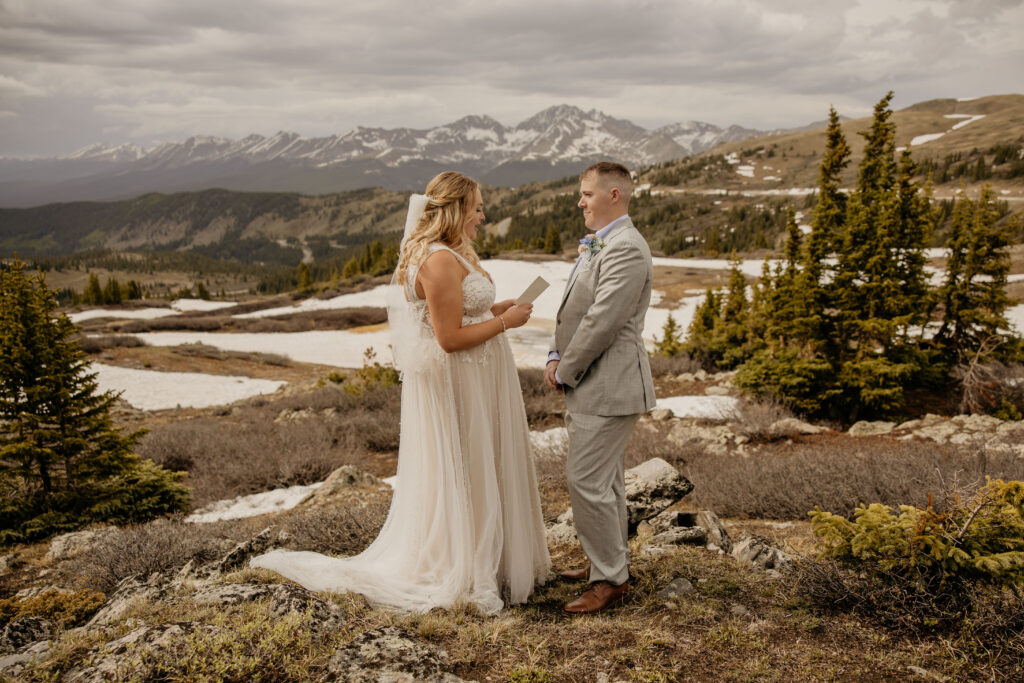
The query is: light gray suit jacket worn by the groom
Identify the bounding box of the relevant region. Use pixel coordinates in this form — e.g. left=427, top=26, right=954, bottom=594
left=551, top=218, right=654, bottom=416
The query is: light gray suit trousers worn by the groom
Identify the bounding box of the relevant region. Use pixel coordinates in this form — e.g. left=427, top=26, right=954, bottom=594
left=565, top=412, right=640, bottom=585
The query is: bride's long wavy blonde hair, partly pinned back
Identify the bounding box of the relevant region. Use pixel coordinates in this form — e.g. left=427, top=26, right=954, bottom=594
left=395, top=171, right=489, bottom=285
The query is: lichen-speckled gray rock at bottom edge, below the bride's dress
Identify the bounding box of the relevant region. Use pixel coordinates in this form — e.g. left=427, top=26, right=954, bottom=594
left=321, top=626, right=463, bottom=683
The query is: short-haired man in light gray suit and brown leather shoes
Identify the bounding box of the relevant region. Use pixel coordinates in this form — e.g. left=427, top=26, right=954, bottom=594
left=544, top=162, right=654, bottom=614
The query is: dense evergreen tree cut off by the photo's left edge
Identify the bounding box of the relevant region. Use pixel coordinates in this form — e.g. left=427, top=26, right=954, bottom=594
left=0, top=261, right=187, bottom=545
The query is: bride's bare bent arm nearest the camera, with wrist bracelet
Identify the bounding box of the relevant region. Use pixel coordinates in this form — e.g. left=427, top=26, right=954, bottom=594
left=416, top=251, right=534, bottom=353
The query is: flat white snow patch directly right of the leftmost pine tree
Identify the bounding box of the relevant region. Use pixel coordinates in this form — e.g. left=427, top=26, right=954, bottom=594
left=92, top=362, right=287, bottom=411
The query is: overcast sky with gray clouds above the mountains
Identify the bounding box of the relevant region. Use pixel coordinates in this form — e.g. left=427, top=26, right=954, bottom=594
left=0, top=0, right=1024, bottom=156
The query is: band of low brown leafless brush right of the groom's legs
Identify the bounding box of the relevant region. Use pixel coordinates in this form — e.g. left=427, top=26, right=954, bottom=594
left=627, top=423, right=1024, bottom=519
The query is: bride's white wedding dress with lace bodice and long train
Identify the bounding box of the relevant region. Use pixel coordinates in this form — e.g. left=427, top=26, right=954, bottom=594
left=252, top=245, right=551, bottom=613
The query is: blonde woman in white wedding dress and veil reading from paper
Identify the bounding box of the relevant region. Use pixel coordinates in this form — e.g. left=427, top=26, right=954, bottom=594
left=252, top=171, right=551, bottom=613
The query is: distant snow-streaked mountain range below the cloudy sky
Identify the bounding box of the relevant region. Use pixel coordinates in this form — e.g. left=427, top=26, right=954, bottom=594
left=0, top=104, right=765, bottom=207
